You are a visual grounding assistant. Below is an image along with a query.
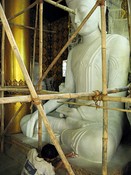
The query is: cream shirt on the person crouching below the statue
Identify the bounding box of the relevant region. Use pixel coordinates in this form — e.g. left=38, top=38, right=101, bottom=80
left=21, top=149, right=55, bottom=175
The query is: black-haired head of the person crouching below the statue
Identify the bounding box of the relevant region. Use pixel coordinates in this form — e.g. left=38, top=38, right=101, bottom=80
left=41, top=143, right=58, bottom=161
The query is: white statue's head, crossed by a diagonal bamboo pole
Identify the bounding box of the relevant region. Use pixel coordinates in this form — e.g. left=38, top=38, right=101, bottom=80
left=67, top=0, right=100, bottom=35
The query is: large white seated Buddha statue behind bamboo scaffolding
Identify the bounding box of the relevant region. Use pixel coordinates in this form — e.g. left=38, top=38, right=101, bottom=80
left=21, top=0, right=129, bottom=163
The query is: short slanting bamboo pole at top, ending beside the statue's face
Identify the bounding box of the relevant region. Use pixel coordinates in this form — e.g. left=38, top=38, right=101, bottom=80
left=44, top=0, right=75, bottom=14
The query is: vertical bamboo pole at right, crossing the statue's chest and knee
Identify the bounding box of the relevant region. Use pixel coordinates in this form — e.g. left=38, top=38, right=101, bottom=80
left=100, top=0, right=108, bottom=175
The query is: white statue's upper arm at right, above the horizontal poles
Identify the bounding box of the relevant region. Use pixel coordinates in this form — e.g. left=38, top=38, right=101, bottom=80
left=108, top=36, right=130, bottom=96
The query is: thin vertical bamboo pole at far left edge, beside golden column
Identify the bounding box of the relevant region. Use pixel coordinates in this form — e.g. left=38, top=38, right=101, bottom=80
left=1, top=0, right=5, bottom=152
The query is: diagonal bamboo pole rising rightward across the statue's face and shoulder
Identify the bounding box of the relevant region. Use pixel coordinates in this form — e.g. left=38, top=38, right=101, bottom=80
left=37, top=0, right=99, bottom=86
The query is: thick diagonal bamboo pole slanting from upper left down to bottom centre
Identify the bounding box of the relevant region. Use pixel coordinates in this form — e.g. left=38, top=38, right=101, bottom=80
left=0, top=3, right=74, bottom=175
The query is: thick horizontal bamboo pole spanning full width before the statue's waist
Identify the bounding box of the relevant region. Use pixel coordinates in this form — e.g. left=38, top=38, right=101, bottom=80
left=0, top=92, right=131, bottom=104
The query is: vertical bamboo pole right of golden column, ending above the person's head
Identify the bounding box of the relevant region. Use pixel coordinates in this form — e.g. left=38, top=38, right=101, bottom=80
left=38, top=2, right=43, bottom=149
